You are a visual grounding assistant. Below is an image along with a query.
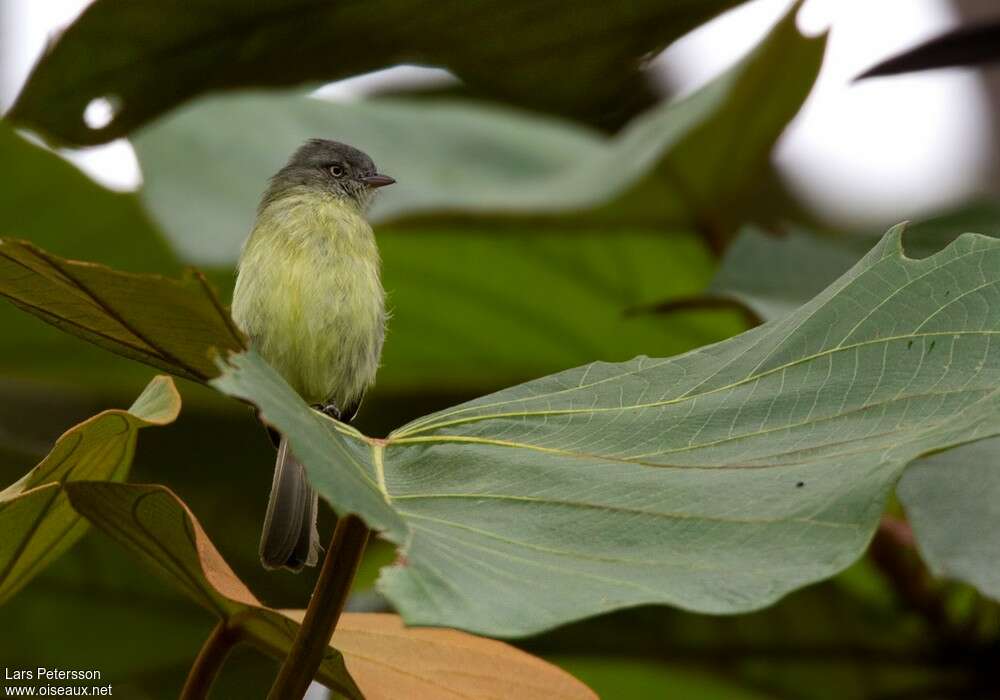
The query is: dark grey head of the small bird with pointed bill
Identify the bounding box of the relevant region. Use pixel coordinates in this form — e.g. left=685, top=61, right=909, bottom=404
left=261, top=139, right=395, bottom=210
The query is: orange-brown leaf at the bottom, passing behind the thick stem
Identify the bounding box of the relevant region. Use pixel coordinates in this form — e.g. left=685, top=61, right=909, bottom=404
left=67, top=482, right=595, bottom=700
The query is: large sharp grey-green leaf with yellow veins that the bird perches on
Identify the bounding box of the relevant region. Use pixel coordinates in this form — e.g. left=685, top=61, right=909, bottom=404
left=212, top=227, right=1000, bottom=636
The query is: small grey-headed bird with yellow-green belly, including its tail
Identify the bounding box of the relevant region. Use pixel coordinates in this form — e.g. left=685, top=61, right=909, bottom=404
left=232, top=139, right=395, bottom=571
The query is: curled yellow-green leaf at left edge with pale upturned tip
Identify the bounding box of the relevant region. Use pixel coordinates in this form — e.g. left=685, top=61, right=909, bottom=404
left=0, top=377, right=181, bottom=604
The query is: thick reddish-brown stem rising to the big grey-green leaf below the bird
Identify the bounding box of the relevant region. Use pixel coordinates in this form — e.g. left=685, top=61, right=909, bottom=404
left=267, top=515, right=369, bottom=700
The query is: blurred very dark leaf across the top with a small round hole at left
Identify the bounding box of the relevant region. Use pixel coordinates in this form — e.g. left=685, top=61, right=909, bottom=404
left=11, top=0, right=752, bottom=144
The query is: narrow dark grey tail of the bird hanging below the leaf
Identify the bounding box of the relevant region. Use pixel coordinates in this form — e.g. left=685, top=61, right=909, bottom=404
left=260, top=437, right=320, bottom=571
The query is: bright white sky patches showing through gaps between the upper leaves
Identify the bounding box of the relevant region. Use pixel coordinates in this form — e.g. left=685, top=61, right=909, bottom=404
left=0, top=0, right=993, bottom=230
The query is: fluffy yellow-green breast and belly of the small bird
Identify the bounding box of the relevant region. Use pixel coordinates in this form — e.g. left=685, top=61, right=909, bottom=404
left=233, top=190, right=385, bottom=408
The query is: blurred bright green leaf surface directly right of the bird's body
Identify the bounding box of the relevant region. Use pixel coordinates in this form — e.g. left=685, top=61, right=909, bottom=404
left=363, top=227, right=746, bottom=396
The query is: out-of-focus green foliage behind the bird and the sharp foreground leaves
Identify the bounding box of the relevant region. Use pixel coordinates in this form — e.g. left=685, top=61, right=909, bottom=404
left=0, top=0, right=1000, bottom=700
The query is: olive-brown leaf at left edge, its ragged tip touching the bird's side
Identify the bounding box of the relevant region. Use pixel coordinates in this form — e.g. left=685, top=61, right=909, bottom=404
left=0, top=239, right=243, bottom=381
